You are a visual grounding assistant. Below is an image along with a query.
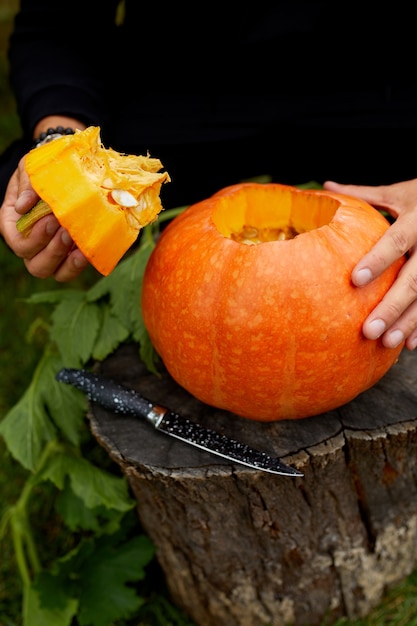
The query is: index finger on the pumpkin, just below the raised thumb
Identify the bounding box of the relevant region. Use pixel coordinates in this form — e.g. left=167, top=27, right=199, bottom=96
left=352, top=213, right=417, bottom=287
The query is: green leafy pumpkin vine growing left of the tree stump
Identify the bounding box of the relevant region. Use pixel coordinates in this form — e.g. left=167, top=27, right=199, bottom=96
left=0, top=209, right=191, bottom=626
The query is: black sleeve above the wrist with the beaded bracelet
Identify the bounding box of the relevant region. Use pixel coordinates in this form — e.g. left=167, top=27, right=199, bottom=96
left=9, top=0, right=118, bottom=135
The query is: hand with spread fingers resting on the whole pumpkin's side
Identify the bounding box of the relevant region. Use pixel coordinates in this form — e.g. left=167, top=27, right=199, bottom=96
left=323, top=178, right=417, bottom=350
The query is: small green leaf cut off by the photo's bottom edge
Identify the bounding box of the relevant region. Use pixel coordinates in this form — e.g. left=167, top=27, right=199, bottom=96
left=23, top=584, right=78, bottom=626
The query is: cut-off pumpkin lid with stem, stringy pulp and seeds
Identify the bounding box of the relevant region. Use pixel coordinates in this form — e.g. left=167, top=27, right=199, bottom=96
left=17, top=126, right=170, bottom=275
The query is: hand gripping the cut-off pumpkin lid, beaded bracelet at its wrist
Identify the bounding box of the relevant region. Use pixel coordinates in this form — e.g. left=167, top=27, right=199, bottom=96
left=0, top=157, right=88, bottom=282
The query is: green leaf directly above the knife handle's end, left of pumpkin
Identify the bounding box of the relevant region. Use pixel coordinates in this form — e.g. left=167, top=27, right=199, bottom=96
left=50, top=292, right=102, bottom=367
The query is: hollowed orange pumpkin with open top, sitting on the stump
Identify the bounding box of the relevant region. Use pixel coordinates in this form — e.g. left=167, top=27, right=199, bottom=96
left=141, top=183, right=404, bottom=421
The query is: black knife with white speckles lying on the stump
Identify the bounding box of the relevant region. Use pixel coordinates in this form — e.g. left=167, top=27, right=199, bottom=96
left=56, top=368, right=303, bottom=477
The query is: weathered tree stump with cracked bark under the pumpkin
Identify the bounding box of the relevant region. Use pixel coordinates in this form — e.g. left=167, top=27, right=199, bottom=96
left=90, top=345, right=417, bottom=626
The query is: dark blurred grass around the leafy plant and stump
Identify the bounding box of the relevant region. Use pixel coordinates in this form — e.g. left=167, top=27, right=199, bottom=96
left=0, top=0, right=417, bottom=626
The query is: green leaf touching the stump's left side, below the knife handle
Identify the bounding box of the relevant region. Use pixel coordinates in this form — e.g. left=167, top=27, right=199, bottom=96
left=42, top=452, right=135, bottom=511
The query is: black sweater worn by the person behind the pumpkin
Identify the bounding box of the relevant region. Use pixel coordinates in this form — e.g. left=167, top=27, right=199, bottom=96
left=4, top=0, right=417, bottom=202
